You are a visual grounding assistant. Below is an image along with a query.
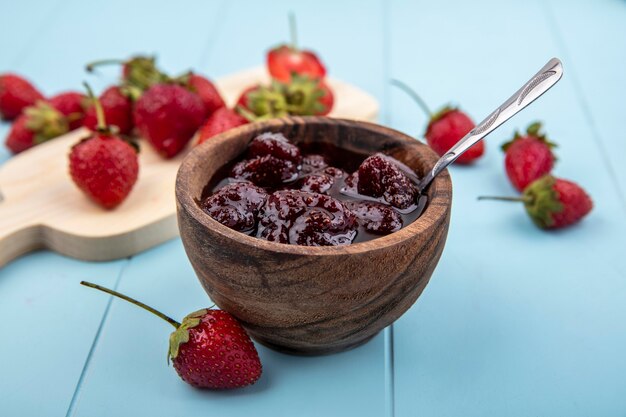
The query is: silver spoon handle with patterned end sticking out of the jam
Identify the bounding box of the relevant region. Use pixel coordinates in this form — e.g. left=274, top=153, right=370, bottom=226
left=417, top=58, right=563, bottom=193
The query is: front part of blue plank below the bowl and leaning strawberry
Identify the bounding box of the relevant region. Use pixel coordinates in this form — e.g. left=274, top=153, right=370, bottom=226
left=72, top=240, right=384, bottom=417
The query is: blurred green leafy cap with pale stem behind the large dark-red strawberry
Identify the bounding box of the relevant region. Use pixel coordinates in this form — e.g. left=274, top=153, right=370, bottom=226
left=85, top=55, right=170, bottom=100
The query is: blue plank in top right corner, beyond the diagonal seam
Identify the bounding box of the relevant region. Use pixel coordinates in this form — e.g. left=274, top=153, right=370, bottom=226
left=543, top=0, right=626, bottom=209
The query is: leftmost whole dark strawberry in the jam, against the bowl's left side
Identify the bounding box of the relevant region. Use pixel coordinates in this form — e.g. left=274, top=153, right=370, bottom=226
left=201, top=182, right=267, bottom=232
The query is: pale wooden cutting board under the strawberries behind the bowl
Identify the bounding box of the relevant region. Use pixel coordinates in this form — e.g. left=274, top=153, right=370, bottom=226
left=0, top=68, right=378, bottom=267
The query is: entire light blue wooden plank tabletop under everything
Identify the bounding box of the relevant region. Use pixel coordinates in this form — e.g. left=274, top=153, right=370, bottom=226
left=0, top=0, right=626, bottom=417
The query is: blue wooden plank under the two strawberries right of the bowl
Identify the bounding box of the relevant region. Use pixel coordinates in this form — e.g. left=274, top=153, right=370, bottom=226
left=390, top=1, right=626, bottom=417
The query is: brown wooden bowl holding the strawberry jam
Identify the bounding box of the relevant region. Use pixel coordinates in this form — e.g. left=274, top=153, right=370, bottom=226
left=176, top=117, right=452, bottom=354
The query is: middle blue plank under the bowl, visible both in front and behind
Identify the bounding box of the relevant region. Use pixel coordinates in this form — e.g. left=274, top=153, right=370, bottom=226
left=71, top=1, right=386, bottom=417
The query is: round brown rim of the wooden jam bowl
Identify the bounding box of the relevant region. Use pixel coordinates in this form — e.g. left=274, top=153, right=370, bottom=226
left=175, top=116, right=452, bottom=256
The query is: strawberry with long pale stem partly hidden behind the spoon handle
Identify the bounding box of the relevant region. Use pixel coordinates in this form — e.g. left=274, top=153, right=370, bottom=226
left=392, top=80, right=485, bottom=164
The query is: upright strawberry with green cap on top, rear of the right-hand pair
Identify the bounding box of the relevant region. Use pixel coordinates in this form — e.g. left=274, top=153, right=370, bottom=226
left=502, top=122, right=556, bottom=192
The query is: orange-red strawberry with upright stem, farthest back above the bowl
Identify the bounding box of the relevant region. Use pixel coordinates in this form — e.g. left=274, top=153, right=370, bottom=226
left=267, top=15, right=326, bottom=82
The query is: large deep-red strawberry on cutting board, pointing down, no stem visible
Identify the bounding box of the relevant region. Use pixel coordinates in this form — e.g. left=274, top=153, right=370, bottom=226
left=133, top=84, right=205, bottom=158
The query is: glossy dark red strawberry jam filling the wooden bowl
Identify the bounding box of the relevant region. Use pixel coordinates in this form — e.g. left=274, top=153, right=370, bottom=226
left=199, top=132, right=426, bottom=246
